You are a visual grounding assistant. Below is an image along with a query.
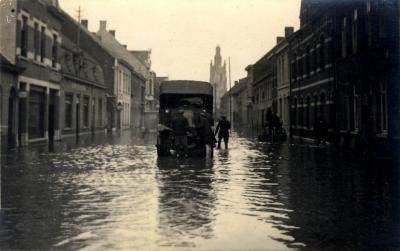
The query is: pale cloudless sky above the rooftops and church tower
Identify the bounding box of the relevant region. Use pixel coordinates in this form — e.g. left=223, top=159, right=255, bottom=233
left=59, top=0, right=300, bottom=85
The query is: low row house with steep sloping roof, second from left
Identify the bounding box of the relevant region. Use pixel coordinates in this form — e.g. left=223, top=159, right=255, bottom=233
left=60, top=34, right=106, bottom=137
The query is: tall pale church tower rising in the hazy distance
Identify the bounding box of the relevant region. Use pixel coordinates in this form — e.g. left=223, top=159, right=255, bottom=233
left=210, top=46, right=227, bottom=118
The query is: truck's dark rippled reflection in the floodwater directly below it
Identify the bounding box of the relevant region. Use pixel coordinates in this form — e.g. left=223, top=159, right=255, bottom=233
left=157, top=158, right=216, bottom=247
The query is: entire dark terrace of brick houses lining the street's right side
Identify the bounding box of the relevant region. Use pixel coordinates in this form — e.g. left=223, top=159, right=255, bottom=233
left=233, top=0, right=400, bottom=155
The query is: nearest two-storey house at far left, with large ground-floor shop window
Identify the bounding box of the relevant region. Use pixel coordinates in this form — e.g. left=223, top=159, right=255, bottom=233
left=0, top=0, right=63, bottom=146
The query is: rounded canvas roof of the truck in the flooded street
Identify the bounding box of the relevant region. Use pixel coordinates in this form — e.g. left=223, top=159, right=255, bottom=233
left=160, top=80, right=213, bottom=95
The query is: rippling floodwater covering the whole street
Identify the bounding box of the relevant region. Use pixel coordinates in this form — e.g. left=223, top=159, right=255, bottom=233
left=0, top=132, right=400, bottom=250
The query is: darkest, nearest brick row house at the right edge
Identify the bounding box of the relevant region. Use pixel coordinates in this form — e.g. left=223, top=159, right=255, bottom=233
left=335, top=0, right=399, bottom=151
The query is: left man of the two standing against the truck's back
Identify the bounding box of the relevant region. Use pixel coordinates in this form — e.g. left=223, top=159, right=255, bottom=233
left=172, top=109, right=189, bottom=157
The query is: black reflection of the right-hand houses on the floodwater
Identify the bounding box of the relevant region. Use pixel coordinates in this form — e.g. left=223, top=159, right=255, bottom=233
left=270, top=145, right=400, bottom=250
